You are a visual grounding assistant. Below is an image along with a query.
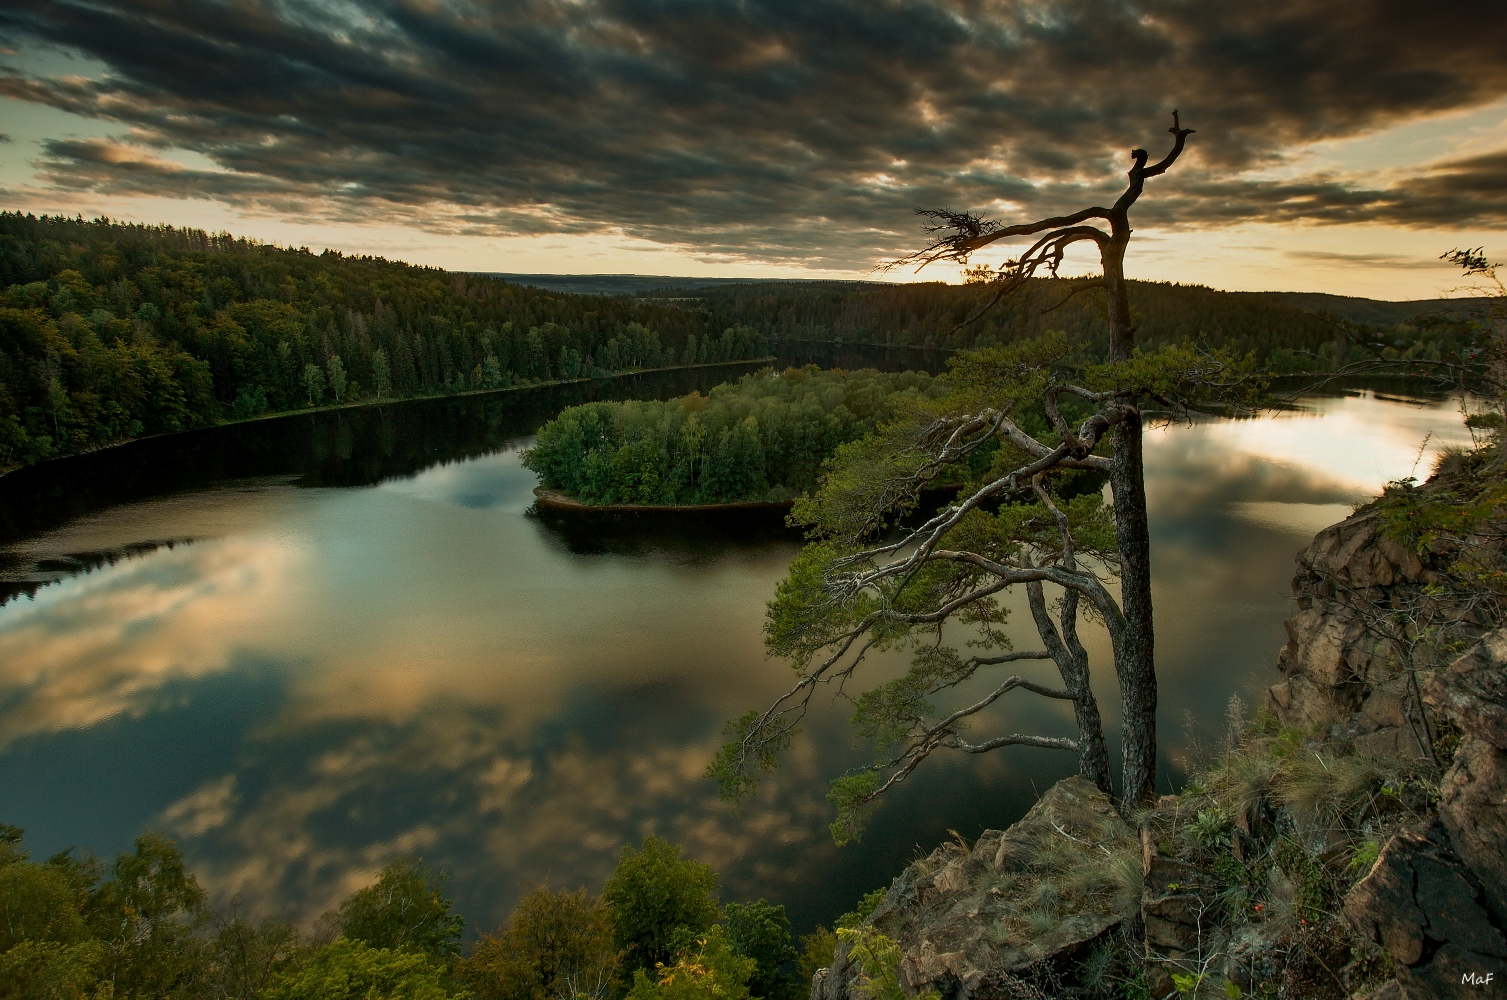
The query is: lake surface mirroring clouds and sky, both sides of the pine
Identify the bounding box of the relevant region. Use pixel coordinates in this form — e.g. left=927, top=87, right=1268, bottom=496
left=0, top=396, right=1465, bottom=926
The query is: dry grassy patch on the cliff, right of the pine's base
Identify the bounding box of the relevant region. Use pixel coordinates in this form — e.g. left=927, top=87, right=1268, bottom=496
left=1144, top=695, right=1439, bottom=998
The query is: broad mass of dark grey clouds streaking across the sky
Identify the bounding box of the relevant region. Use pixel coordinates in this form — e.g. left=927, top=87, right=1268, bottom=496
left=0, top=0, right=1507, bottom=267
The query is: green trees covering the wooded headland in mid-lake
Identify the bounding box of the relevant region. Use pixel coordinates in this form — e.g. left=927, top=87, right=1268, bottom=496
left=523, top=366, right=942, bottom=505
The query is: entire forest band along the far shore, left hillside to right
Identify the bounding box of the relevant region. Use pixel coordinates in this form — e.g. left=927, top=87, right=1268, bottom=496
left=0, top=212, right=1480, bottom=470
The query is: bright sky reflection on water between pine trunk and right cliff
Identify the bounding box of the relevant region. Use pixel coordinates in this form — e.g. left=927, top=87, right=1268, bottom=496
left=1145, top=393, right=1469, bottom=761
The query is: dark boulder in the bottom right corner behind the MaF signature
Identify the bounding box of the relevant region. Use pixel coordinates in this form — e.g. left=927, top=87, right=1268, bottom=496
left=1344, top=822, right=1507, bottom=1000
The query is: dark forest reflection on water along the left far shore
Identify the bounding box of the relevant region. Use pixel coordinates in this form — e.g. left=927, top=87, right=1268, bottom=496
left=0, top=363, right=771, bottom=544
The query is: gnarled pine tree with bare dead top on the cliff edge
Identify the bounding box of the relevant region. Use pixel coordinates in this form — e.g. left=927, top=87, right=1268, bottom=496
left=711, top=113, right=1251, bottom=842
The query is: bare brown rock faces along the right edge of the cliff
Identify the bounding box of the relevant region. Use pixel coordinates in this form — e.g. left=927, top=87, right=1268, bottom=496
left=1266, top=511, right=1507, bottom=1000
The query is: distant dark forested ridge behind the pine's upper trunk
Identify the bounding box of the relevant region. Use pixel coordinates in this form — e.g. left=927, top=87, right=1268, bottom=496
left=640, top=279, right=1475, bottom=370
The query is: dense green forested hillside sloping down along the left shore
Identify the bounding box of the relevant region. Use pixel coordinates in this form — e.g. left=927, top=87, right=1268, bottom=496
left=0, top=212, right=769, bottom=468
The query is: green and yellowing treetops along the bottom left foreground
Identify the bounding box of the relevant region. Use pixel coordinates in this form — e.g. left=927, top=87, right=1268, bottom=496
left=0, top=824, right=894, bottom=1000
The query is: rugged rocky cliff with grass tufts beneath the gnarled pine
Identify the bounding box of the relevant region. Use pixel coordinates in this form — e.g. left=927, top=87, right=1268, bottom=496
left=812, top=509, right=1507, bottom=1000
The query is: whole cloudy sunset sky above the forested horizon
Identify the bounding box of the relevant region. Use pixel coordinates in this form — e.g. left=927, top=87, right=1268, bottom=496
left=0, top=0, right=1507, bottom=300
